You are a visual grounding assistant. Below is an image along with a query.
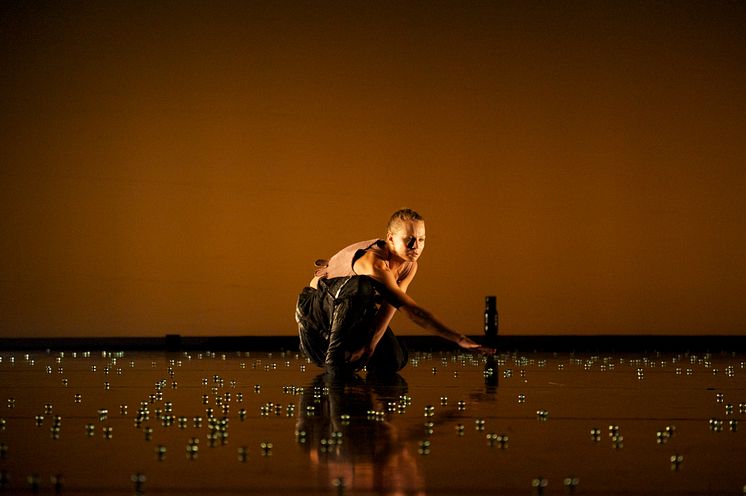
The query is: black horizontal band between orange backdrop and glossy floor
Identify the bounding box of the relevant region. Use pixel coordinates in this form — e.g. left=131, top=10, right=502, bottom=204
left=0, top=334, right=746, bottom=353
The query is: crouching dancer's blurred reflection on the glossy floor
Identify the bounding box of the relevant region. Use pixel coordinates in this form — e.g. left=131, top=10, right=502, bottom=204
left=296, top=374, right=425, bottom=494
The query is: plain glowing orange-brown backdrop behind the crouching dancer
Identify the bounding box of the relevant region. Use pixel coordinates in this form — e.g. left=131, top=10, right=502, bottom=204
left=0, top=1, right=746, bottom=337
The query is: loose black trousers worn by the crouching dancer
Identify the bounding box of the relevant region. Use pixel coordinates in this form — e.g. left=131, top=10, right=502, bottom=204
left=295, top=276, right=408, bottom=374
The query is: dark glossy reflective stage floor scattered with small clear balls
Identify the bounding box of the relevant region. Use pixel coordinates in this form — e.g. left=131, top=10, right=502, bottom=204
left=0, top=352, right=746, bottom=495
